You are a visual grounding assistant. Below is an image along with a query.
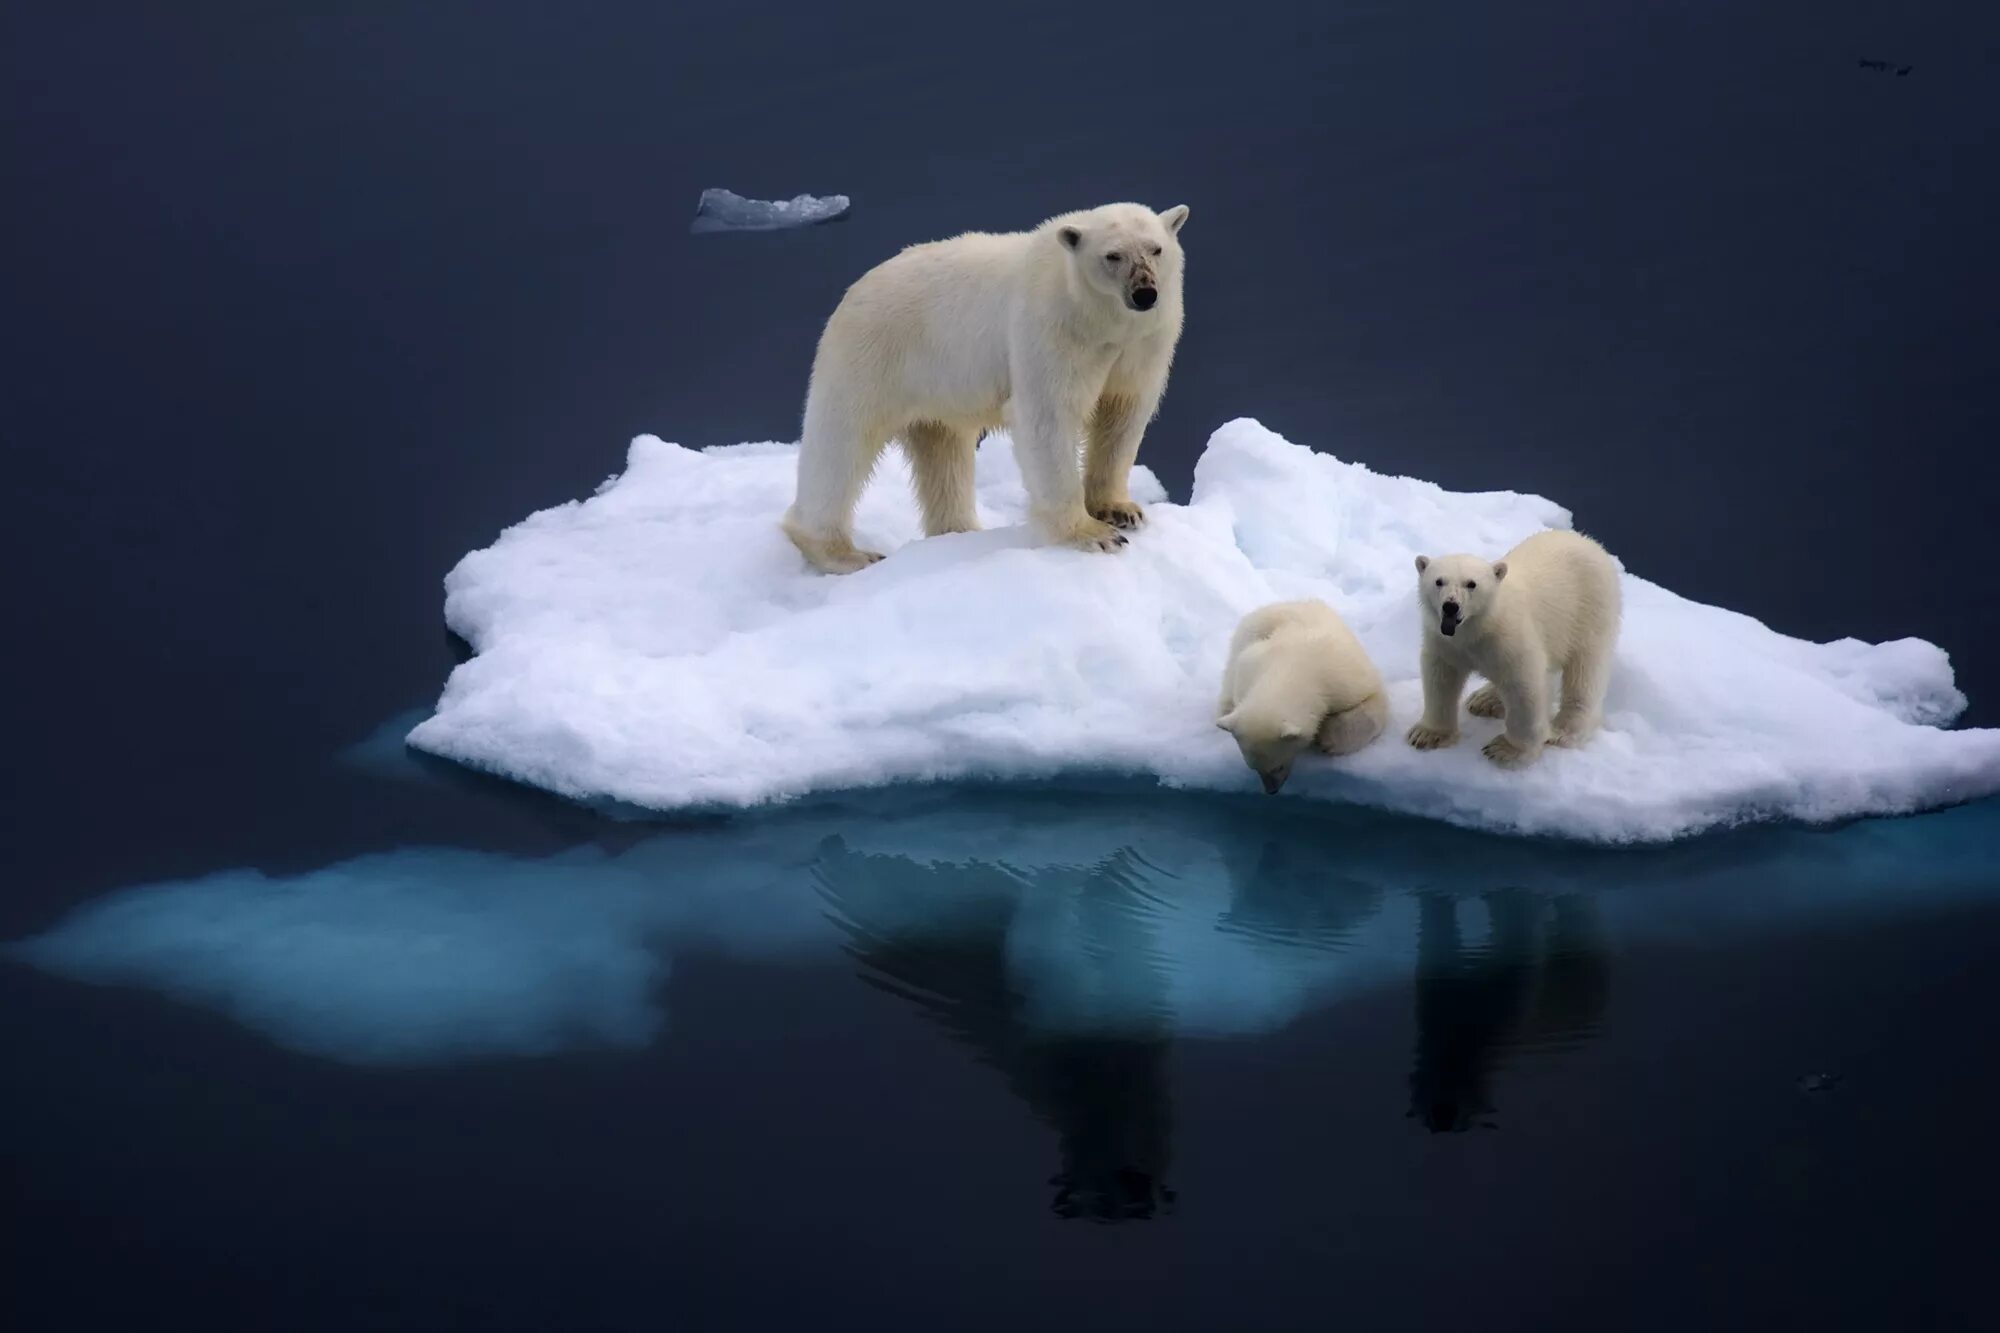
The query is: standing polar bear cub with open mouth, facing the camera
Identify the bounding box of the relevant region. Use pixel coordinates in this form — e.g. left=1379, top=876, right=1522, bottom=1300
left=1408, top=530, right=1620, bottom=769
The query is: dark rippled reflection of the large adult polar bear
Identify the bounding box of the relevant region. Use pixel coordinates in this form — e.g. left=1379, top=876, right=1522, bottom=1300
left=816, top=839, right=1174, bottom=1221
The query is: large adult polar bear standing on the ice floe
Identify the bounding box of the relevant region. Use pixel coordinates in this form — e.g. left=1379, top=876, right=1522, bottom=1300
left=784, top=204, right=1188, bottom=574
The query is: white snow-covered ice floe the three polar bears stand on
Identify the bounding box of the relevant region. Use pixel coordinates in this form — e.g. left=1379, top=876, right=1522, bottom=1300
left=410, top=420, right=2000, bottom=843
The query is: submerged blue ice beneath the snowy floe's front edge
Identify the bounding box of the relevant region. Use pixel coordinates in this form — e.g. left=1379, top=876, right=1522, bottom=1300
left=6, top=791, right=2000, bottom=1065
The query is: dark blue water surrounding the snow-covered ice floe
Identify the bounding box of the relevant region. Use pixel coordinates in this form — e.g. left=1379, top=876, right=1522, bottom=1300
left=0, top=0, right=2000, bottom=1329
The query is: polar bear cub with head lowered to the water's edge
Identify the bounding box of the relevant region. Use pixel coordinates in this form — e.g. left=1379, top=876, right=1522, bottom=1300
left=1216, top=600, right=1388, bottom=795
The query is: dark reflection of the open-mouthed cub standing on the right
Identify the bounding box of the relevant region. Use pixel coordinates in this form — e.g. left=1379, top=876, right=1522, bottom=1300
left=1410, top=889, right=1606, bottom=1133
